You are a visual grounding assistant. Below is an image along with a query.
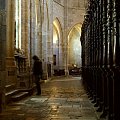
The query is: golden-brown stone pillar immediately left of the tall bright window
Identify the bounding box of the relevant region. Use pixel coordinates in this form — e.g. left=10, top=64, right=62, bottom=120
left=6, top=0, right=16, bottom=84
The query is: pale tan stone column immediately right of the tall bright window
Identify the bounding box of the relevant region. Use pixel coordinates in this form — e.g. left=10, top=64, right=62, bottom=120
left=21, top=0, right=30, bottom=68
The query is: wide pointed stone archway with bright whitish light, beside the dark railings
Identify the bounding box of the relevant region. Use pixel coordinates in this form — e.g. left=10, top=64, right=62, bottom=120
left=68, top=23, right=81, bottom=69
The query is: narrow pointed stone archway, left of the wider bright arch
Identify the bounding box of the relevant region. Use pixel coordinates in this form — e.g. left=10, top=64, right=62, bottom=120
left=53, top=18, right=63, bottom=75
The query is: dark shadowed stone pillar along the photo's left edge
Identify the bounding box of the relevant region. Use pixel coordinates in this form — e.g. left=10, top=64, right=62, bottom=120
left=0, top=0, right=6, bottom=112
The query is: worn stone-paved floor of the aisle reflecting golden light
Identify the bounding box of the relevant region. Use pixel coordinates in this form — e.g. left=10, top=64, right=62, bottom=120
left=0, top=77, right=105, bottom=120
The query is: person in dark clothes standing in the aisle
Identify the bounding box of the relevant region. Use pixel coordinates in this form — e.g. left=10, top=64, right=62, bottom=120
left=32, top=55, right=42, bottom=95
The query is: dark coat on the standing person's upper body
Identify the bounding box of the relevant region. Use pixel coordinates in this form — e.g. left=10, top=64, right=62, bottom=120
left=33, top=60, right=42, bottom=75
